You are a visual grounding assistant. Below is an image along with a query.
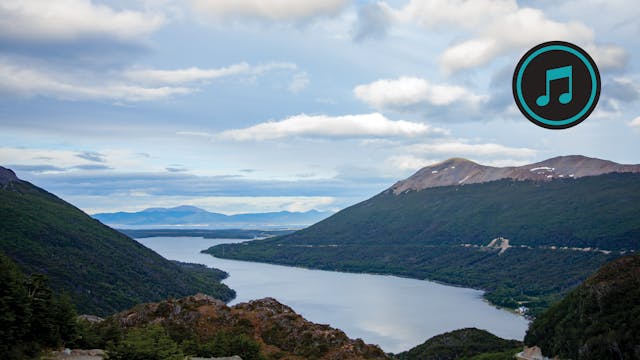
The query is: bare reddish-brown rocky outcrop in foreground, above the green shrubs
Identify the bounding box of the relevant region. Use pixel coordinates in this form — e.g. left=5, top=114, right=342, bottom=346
left=106, top=294, right=388, bottom=360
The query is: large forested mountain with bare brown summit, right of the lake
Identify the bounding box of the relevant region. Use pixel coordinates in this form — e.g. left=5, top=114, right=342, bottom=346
left=208, top=156, right=640, bottom=315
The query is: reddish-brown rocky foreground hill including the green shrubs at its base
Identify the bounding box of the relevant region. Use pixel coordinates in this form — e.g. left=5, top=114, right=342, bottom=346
left=82, top=294, right=388, bottom=360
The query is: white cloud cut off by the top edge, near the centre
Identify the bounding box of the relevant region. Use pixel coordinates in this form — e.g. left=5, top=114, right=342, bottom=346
left=191, top=0, right=350, bottom=22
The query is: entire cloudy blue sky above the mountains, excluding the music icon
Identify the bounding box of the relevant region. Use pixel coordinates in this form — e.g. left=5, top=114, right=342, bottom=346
left=0, top=0, right=640, bottom=214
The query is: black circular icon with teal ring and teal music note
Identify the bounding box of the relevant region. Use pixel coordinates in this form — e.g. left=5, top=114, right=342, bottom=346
left=512, top=41, right=600, bottom=129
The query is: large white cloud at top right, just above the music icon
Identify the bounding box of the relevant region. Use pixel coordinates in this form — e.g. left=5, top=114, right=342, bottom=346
left=386, top=0, right=627, bottom=73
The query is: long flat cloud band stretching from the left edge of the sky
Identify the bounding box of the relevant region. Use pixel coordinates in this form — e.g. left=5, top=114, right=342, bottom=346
left=0, top=57, right=297, bottom=102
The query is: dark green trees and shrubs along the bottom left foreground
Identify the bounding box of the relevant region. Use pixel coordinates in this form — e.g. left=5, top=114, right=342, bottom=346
left=0, top=253, right=262, bottom=360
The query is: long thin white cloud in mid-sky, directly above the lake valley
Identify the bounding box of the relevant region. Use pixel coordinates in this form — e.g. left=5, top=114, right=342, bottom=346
left=219, top=113, right=447, bottom=141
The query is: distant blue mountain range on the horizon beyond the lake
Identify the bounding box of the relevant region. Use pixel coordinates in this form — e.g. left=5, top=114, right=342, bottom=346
left=93, top=206, right=332, bottom=227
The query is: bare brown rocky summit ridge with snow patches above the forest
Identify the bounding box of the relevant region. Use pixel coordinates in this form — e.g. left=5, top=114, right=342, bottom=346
left=389, top=155, right=640, bottom=194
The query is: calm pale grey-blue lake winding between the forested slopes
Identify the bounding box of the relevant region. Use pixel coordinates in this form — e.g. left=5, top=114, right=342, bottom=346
left=137, top=237, right=528, bottom=353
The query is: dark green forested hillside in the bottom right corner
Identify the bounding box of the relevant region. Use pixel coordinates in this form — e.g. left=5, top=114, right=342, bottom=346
left=525, top=254, right=640, bottom=360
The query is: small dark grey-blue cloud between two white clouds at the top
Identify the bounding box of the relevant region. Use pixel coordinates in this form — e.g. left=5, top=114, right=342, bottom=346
left=353, top=2, right=392, bottom=41
